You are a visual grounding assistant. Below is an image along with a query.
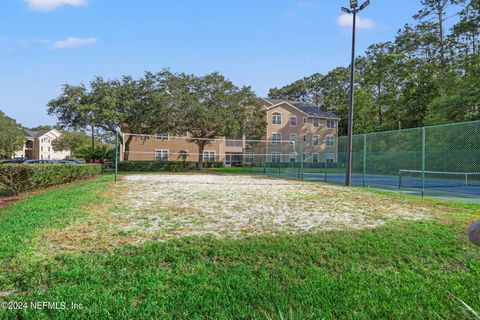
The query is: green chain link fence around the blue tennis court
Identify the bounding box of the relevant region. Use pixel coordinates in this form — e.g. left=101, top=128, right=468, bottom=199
left=243, top=121, right=480, bottom=199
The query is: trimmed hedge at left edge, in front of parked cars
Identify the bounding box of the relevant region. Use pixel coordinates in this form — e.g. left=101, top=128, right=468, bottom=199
left=0, top=164, right=102, bottom=195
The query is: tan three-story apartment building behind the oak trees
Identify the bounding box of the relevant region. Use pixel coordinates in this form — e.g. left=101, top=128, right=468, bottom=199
left=121, top=99, right=339, bottom=166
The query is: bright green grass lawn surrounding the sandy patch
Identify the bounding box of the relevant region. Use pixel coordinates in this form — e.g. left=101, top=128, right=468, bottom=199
left=0, top=176, right=480, bottom=319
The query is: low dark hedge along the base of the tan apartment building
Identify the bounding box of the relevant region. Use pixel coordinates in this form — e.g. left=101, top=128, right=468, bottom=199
left=109, top=161, right=223, bottom=172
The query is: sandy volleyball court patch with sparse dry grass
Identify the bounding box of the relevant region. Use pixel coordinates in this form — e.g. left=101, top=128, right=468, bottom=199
left=38, top=174, right=433, bottom=252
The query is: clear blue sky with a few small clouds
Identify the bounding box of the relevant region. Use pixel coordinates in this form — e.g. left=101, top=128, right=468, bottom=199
left=0, top=0, right=428, bottom=127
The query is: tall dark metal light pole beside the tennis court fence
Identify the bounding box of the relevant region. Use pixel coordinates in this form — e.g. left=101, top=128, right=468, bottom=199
left=342, top=0, right=370, bottom=186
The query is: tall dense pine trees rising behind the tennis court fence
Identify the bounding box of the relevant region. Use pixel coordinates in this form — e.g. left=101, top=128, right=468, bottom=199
left=269, top=0, right=480, bottom=134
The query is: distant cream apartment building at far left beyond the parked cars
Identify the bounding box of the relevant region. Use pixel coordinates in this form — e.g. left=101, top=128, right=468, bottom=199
left=13, top=129, right=70, bottom=160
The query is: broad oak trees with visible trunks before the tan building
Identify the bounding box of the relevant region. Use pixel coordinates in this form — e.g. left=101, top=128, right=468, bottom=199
left=48, top=70, right=266, bottom=168
